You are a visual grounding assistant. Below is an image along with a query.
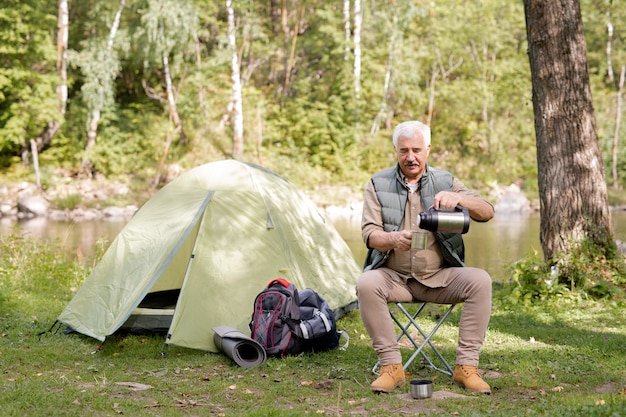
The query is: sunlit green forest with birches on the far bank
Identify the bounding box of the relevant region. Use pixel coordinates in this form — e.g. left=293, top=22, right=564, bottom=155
left=0, top=0, right=626, bottom=198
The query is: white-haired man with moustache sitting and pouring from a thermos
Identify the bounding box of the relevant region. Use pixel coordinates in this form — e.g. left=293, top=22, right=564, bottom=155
left=357, top=121, right=494, bottom=394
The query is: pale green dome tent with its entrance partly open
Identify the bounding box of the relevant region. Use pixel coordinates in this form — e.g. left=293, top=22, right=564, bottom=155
left=58, top=160, right=361, bottom=352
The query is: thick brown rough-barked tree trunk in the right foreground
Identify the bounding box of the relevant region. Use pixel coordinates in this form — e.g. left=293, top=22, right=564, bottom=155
left=524, top=0, right=612, bottom=261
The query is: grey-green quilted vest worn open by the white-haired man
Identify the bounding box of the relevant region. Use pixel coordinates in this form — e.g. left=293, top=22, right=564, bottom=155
left=363, top=165, right=465, bottom=271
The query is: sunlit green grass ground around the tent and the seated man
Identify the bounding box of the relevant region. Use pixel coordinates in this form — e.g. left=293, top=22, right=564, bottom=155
left=0, top=237, right=626, bottom=417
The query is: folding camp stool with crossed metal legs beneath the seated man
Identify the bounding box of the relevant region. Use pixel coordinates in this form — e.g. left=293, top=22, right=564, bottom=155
left=372, top=301, right=455, bottom=376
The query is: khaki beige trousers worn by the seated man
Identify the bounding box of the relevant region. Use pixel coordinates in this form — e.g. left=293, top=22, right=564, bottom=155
left=356, top=267, right=491, bottom=366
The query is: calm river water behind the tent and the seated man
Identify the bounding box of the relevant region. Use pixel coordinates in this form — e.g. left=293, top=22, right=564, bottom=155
left=0, top=211, right=626, bottom=281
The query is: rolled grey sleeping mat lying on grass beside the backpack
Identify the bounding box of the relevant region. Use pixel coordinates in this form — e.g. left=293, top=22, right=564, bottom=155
left=213, top=326, right=267, bottom=368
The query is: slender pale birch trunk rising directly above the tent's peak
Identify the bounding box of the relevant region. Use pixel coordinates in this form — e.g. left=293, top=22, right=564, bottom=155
left=226, top=0, right=243, bottom=159
